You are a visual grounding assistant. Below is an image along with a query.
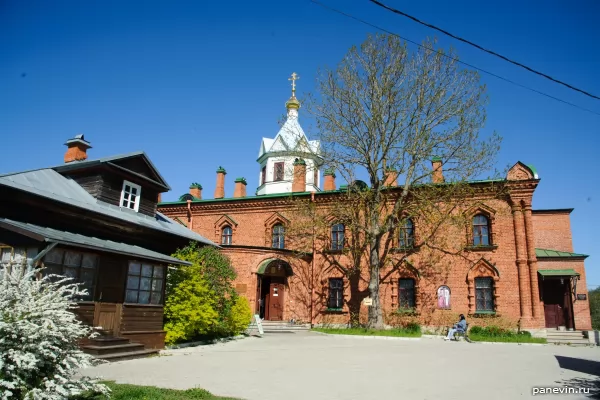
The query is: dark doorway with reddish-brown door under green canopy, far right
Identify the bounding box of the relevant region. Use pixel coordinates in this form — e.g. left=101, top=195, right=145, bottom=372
left=543, top=278, right=572, bottom=328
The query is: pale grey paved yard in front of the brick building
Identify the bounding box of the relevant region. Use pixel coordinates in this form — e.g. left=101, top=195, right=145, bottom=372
left=85, top=333, right=600, bottom=400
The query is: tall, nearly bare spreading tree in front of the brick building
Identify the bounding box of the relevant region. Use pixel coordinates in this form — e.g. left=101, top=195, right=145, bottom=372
left=298, top=35, right=501, bottom=328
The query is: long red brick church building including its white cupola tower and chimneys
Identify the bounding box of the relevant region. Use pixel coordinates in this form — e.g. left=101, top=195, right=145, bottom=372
left=158, top=90, right=591, bottom=334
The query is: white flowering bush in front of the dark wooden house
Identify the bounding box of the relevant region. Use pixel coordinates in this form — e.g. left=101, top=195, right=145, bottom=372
left=0, top=263, right=110, bottom=400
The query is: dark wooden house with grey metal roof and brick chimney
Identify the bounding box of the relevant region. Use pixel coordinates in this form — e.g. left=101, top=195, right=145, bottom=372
left=0, top=135, right=214, bottom=358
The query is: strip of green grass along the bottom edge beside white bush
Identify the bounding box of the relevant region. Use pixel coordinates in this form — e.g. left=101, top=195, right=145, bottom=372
left=71, top=382, right=239, bottom=400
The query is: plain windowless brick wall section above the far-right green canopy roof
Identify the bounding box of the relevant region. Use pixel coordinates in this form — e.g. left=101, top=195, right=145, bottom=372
left=533, top=211, right=573, bottom=252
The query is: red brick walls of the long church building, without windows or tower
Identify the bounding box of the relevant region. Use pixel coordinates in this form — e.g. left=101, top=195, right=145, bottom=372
left=161, top=194, right=589, bottom=329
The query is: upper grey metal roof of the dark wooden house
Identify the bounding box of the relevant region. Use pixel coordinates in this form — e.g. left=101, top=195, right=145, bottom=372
left=0, top=168, right=216, bottom=246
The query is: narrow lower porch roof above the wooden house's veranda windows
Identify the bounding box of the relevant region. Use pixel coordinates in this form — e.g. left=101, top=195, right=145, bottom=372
left=0, top=218, right=191, bottom=265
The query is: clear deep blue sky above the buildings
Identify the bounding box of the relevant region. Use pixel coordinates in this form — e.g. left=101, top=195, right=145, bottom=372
left=0, top=0, right=600, bottom=285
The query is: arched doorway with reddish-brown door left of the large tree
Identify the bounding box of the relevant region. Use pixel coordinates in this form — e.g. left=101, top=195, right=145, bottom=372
left=256, top=258, right=294, bottom=321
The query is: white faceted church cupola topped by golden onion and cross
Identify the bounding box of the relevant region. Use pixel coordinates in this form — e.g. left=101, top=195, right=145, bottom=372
left=256, top=72, right=322, bottom=196
